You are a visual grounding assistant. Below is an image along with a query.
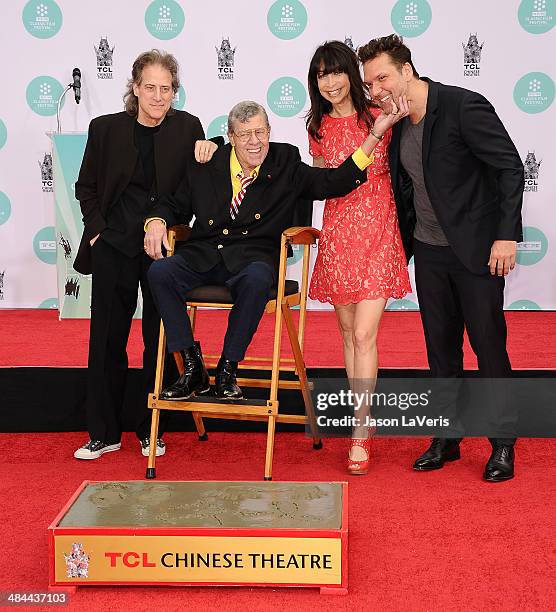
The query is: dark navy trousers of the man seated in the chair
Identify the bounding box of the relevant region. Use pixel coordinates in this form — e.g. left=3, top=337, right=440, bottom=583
left=148, top=255, right=276, bottom=361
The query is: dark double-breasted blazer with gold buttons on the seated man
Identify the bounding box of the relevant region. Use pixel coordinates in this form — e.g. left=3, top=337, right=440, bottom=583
left=153, top=142, right=367, bottom=273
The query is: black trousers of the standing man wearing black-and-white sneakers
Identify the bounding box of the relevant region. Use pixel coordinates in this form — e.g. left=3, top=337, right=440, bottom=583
left=87, top=238, right=167, bottom=444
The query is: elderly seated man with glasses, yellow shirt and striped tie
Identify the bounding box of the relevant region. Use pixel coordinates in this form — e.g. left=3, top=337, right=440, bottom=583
left=145, top=101, right=397, bottom=400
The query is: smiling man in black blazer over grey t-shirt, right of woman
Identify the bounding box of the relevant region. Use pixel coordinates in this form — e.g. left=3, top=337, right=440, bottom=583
left=358, top=34, right=523, bottom=482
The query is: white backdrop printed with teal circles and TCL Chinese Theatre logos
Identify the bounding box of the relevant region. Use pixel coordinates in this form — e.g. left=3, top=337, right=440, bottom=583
left=0, top=0, right=556, bottom=310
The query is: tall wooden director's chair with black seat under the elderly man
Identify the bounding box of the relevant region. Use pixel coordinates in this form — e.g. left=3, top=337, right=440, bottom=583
left=146, top=226, right=322, bottom=480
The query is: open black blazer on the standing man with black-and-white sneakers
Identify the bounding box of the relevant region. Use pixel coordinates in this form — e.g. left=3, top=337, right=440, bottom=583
left=73, top=111, right=205, bottom=274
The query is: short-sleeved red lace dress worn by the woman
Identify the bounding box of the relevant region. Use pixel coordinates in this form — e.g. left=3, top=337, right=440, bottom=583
left=309, top=114, right=411, bottom=304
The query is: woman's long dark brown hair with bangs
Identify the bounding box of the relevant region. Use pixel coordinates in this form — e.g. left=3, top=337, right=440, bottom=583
left=305, top=40, right=373, bottom=140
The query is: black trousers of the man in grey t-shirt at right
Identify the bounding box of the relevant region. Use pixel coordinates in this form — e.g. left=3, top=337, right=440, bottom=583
left=414, top=240, right=515, bottom=445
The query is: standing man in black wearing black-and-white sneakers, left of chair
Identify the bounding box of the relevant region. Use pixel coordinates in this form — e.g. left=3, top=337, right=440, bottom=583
left=74, top=49, right=216, bottom=459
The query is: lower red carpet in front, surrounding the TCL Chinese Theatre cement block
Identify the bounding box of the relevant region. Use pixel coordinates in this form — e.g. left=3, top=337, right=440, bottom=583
left=0, top=433, right=556, bottom=612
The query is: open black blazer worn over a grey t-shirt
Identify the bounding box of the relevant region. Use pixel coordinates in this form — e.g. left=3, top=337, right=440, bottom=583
left=390, top=78, right=524, bottom=274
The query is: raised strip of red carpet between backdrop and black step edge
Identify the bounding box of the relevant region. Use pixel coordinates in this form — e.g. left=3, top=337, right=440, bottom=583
left=0, top=310, right=556, bottom=370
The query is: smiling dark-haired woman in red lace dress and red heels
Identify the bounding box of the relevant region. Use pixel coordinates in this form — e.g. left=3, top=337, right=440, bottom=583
left=307, top=41, right=411, bottom=474
